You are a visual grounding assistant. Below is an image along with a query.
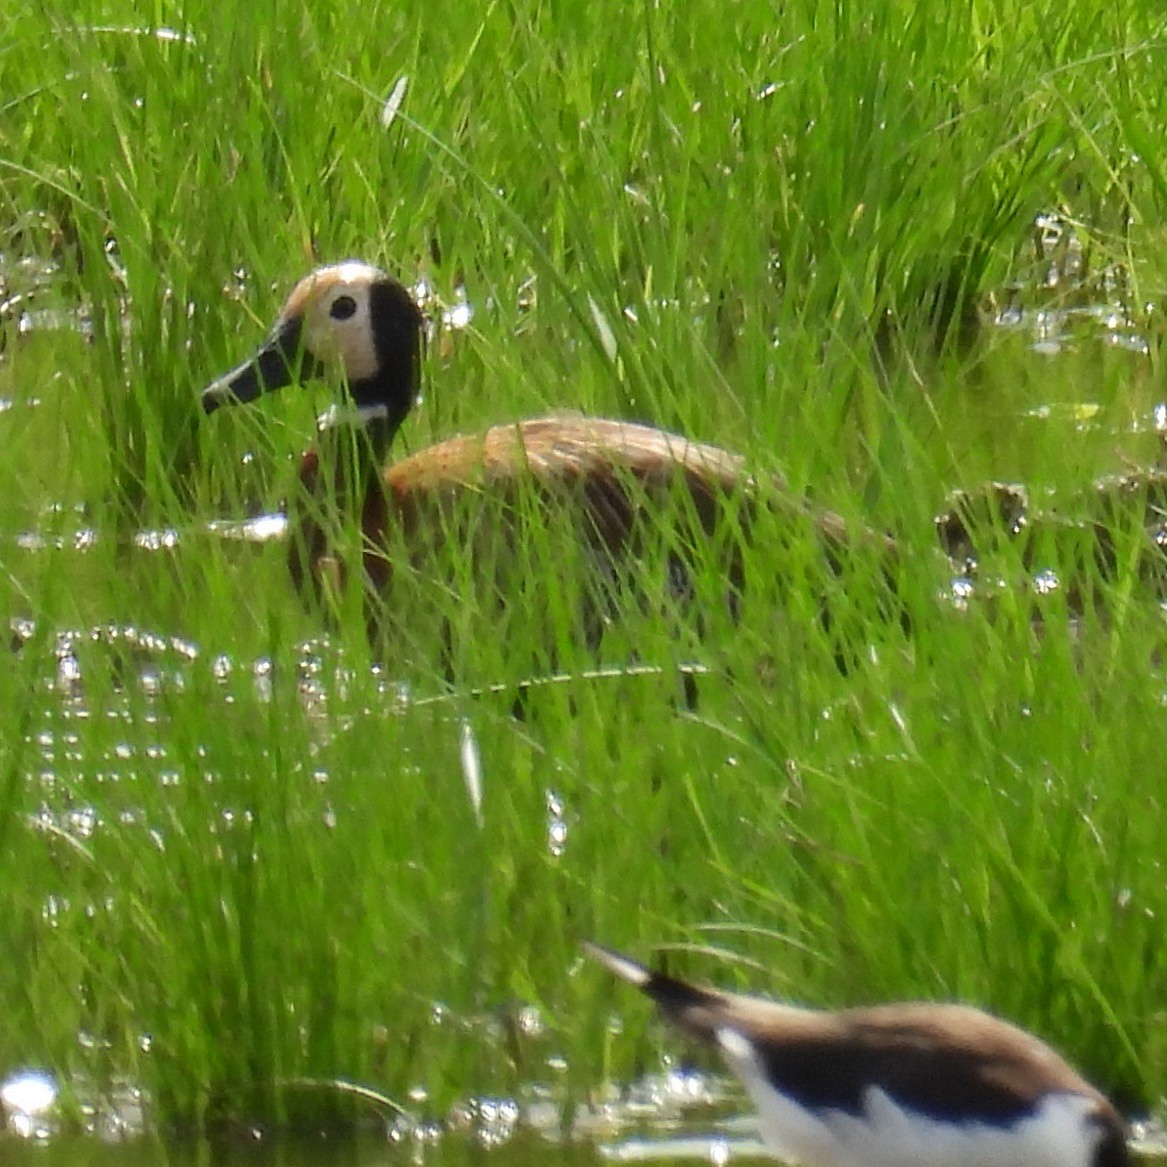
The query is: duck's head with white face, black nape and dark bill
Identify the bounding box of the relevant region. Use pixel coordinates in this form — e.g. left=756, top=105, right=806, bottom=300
left=202, top=260, right=422, bottom=441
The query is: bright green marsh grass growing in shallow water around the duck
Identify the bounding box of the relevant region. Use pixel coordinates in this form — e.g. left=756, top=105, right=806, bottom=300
left=0, top=0, right=1167, bottom=1128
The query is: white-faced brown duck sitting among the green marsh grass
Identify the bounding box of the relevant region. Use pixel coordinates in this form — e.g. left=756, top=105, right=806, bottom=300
left=201, top=260, right=894, bottom=662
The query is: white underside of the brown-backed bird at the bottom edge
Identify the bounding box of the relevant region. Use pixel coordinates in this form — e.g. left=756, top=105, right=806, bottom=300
left=717, top=1028, right=1100, bottom=1167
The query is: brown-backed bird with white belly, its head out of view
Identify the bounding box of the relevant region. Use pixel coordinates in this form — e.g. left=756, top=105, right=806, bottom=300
left=584, top=942, right=1130, bottom=1167
